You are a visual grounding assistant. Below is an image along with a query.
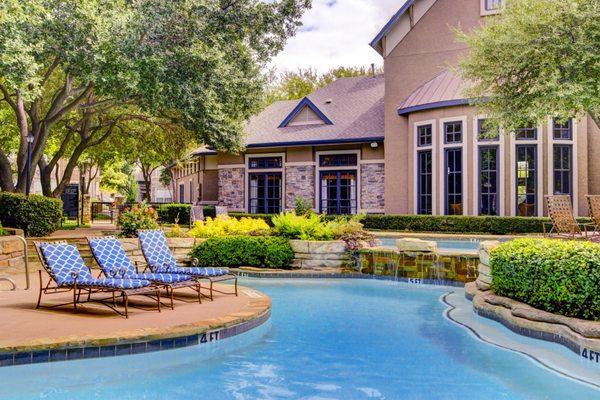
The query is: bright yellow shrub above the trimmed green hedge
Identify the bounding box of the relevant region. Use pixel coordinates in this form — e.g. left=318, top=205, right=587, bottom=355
left=189, top=216, right=270, bottom=238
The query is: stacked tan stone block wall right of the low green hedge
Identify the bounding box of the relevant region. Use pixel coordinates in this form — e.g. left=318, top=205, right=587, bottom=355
left=290, top=240, right=348, bottom=272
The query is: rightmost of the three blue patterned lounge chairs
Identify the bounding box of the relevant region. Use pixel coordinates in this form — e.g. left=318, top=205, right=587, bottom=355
left=138, top=230, right=238, bottom=301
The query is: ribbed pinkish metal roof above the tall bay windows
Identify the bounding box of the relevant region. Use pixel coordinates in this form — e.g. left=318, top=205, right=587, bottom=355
left=398, top=70, right=471, bottom=115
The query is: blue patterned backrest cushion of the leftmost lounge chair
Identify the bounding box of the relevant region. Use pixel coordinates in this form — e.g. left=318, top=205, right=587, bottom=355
left=41, top=243, right=94, bottom=286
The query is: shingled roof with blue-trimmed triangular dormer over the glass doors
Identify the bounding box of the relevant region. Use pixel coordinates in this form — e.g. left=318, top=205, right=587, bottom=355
left=245, top=75, right=384, bottom=147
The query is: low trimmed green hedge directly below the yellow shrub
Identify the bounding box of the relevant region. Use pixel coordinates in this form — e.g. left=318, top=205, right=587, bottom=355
left=190, top=236, right=294, bottom=268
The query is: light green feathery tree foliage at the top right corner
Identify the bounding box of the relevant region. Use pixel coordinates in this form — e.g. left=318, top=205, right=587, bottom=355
left=458, top=0, right=600, bottom=132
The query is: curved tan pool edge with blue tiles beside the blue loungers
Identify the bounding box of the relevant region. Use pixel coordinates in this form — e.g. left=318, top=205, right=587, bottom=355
left=0, top=289, right=272, bottom=367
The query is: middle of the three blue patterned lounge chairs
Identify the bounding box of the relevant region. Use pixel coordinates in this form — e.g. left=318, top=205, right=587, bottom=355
left=87, top=236, right=202, bottom=309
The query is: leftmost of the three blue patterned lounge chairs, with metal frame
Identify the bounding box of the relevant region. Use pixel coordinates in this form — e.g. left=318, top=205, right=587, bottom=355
left=34, top=242, right=160, bottom=318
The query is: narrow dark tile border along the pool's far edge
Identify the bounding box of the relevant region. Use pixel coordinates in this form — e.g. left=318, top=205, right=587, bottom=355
left=232, top=271, right=465, bottom=287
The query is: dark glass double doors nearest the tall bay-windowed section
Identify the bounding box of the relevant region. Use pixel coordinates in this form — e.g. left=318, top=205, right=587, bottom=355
left=320, top=171, right=358, bottom=215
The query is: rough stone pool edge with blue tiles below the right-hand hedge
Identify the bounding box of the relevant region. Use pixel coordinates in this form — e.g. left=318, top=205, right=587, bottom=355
left=465, top=283, right=600, bottom=365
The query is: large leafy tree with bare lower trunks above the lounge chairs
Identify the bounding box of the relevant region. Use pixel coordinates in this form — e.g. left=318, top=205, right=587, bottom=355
left=0, top=0, right=310, bottom=194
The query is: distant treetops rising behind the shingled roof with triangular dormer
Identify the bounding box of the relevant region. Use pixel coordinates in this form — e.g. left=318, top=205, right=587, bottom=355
left=265, top=67, right=383, bottom=105
